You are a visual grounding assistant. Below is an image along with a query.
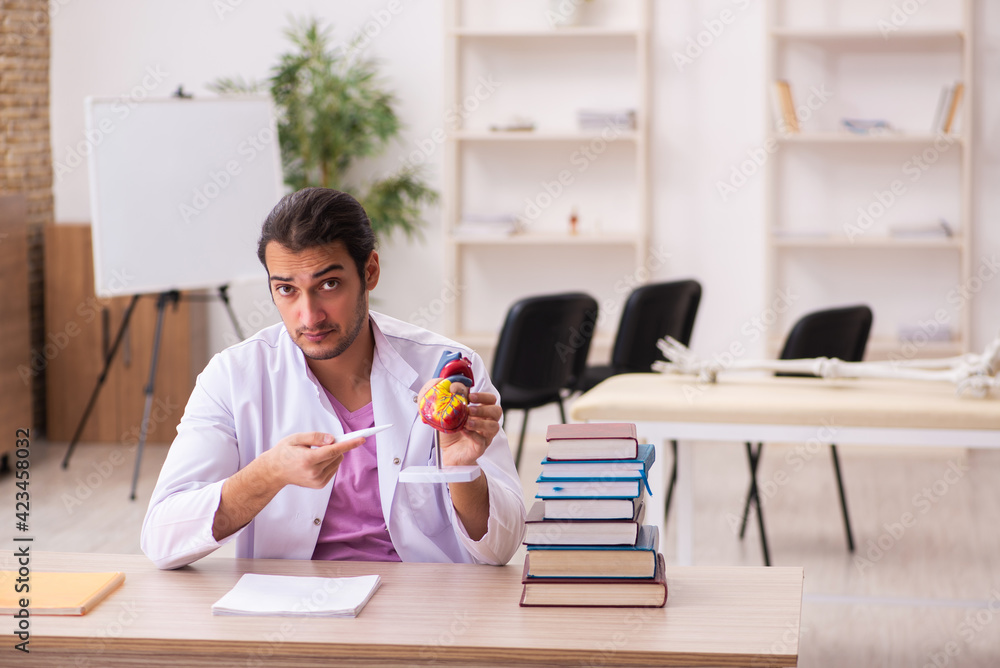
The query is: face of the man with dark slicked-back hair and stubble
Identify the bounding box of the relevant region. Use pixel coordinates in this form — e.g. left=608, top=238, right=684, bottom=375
left=264, top=241, right=379, bottom=360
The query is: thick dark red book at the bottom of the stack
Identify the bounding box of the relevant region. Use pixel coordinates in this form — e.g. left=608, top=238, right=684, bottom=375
left=520, top=554, right=667, bottom=608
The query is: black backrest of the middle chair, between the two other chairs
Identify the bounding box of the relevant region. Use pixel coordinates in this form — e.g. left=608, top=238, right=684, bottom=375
left=611, top=280, right=701, bottom=373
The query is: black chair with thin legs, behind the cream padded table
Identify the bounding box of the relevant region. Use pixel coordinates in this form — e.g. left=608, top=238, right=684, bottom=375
left=740, top=305, right=872, bottom=566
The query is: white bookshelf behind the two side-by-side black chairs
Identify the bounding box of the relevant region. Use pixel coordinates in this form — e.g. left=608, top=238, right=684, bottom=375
left=442, top=0, right=652, bottom=351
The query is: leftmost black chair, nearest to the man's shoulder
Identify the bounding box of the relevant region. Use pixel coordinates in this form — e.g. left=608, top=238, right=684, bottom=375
left=492, top=292, right=597, bottom=466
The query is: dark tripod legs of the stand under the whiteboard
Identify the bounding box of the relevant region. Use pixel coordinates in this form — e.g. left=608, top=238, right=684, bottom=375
left=62, top=285, right=243, bottom=501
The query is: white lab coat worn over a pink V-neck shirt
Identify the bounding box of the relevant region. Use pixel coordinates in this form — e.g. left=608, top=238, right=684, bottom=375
left=141, top=312, right=525, bottom=568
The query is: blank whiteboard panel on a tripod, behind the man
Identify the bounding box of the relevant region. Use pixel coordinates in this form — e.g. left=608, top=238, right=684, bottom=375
left=85, top=96, right=284, bottom=297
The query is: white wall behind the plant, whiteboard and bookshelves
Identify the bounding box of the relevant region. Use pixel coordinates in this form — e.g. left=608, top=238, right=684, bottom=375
left=51, top=0, right=1000, bottom=366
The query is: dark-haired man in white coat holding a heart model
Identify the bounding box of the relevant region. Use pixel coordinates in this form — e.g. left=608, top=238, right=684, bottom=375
left=141, top=188, right=525, bottom=568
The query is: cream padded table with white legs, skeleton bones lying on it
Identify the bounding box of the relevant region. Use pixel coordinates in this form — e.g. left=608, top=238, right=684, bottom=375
left=570, top=373, right=1000, bottom=564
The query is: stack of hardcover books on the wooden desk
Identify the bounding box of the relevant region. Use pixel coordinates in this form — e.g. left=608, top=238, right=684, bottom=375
left=521, top=423, right=667, bottom=607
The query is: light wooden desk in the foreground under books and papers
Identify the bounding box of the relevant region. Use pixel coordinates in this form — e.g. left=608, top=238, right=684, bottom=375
left=7, top=551, right=802, bottom=668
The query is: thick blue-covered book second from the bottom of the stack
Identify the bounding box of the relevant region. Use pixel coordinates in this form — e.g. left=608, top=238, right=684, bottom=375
left=528, top=524, right=660, bottom=578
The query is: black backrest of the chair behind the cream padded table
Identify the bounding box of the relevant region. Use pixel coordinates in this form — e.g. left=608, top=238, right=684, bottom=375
left=779, top=304, right=872, bottom=375
